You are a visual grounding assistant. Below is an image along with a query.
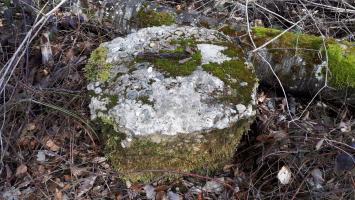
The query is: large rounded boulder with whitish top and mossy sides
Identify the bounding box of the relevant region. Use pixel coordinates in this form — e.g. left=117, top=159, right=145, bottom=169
left=85, top=25, right=257, bottom=181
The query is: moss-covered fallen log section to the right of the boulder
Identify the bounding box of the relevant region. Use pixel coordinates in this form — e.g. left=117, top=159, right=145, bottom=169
left=245, top=28, right=355, bottom=106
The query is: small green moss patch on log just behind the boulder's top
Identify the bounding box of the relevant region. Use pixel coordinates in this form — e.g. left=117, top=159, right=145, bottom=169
left=135, top=7, right=175, bottom=28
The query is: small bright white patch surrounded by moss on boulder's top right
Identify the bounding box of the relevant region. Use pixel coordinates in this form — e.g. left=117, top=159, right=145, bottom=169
left=197, top=44, right=231, bottom=64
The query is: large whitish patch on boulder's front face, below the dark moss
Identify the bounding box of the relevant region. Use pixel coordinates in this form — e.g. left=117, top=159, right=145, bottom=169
left=108, top=68, right=238, bottom=135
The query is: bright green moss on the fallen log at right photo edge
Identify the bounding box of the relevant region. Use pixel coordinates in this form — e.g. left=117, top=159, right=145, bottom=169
left=327, top=44, right=355, bottom=88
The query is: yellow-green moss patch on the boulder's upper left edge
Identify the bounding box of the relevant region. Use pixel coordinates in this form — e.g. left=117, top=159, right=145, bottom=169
left=85, top=47, right=112, bottom=82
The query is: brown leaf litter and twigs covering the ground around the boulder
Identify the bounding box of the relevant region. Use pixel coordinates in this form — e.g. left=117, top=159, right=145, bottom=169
left=0, top=0, right=355, bottom=200
